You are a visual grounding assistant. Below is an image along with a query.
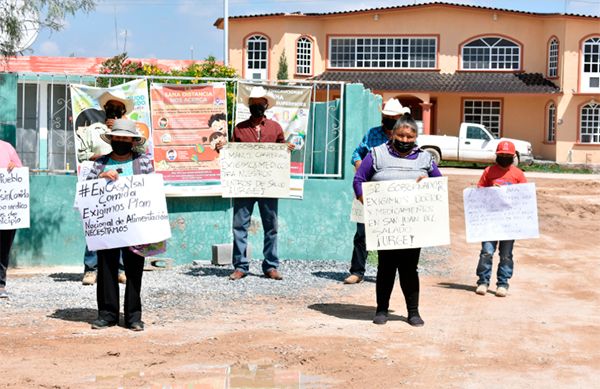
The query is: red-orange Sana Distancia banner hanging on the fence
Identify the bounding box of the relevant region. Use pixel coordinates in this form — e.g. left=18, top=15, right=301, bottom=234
left=150, top=82, right=228, bottom=195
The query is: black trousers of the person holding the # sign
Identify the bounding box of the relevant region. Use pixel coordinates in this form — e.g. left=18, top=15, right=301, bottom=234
left=96, top=247, right=144, bottom=327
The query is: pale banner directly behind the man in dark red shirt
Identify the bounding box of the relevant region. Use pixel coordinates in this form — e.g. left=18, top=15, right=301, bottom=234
left=235, top=82, right=312, bottom=199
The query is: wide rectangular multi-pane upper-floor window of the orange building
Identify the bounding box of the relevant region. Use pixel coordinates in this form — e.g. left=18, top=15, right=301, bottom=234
left=329, top=36, right=437, bottom=69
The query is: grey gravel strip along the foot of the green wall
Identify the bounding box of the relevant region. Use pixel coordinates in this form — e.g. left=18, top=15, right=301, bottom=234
left=0, top=247, right=450, bottom=326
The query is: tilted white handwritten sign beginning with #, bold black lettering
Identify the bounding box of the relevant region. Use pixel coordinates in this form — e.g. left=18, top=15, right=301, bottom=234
left=75, top=174, right=171, bottom=251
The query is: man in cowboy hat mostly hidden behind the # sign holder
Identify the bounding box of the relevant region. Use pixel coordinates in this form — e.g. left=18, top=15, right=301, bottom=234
left=77, top=90, right=139, bottom=285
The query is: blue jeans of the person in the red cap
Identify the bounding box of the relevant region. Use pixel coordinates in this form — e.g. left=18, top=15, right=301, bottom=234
left=477, top=240, right=515, bottom=288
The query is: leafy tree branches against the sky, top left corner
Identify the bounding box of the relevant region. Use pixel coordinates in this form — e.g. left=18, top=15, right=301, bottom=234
left=0, top=0, right=96, bottom=59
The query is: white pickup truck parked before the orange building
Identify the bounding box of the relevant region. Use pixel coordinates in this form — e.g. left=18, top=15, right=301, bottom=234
left=417, top=123, right=533, bottom=165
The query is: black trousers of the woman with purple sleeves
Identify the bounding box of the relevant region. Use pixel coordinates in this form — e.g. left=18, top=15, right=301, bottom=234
left=375, top=248, right=421, bottom=316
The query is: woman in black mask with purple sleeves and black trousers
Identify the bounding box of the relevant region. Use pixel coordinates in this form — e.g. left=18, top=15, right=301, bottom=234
left=353, top=115, right=442, bottom=327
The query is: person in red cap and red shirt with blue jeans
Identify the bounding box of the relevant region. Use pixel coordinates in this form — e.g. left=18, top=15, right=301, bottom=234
left=475, top=140, right=527, bottom=297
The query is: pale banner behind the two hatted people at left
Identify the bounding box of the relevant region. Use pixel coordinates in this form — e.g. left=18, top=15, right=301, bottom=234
left=70, top=80, right=153, bottom=168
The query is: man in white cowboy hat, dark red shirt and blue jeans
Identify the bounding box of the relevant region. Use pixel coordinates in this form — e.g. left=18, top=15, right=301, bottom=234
left=217, top=86, right=294, bottom=281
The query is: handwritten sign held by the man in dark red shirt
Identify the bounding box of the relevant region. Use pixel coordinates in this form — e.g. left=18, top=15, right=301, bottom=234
left=220, top=143, right=290, bottom=198
